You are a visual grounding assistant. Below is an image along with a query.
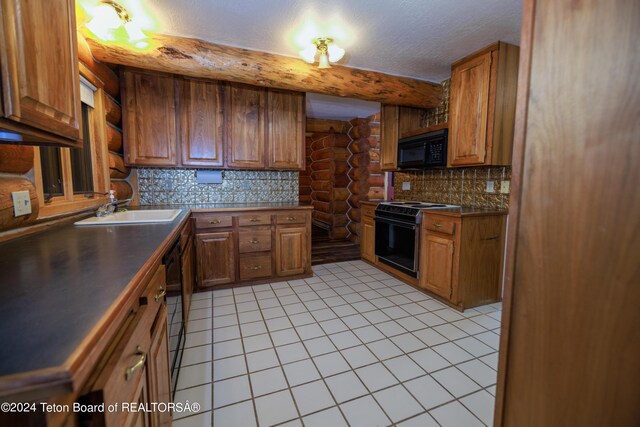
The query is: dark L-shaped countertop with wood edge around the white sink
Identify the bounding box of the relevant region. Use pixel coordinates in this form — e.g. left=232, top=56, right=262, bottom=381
left=0, top=203, right=312, bottom=383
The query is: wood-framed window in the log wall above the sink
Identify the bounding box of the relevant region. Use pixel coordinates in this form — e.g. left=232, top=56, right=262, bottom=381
left=34, top=73, right=109, bottom=217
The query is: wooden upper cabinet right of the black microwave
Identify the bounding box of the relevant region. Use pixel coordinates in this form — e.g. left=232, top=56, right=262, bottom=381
left=448, top=42, right=519, bottom=166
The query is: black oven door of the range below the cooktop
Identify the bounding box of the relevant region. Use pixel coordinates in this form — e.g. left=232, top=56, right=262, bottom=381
left=375, top=217, right=419, bottom=277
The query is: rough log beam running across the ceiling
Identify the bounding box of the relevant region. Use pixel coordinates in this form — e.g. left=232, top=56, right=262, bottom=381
left=85, top=34, right=442, bottom=108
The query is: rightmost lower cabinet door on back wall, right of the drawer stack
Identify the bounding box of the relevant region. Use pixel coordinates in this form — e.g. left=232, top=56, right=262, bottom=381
left=276, top=227, right=311, bottom=276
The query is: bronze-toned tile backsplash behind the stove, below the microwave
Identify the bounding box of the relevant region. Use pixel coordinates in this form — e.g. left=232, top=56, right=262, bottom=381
left=393, top=166, right=511, bottom=209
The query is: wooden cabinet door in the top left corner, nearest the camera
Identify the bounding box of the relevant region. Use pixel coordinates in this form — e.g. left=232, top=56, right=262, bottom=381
left=0, top=0, right=80, bottom=145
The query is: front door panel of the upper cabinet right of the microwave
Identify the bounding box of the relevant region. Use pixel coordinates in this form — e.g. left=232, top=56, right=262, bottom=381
left=448, top=52, right=491, bottom=166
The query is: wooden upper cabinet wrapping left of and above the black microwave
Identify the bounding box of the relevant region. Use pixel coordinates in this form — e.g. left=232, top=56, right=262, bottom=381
left=380, top=104, right=426, bottom=171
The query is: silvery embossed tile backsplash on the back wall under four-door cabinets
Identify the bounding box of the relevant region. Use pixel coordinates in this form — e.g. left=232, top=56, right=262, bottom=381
left=137, top=168, right=298, bottom=205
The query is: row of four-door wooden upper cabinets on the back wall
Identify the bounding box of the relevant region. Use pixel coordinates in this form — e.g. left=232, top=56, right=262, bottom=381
left=123, top=71, right=305, bottom=170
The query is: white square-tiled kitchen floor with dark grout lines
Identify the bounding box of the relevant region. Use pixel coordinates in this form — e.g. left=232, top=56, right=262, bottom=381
left=174, top=261, right=501, bottom=427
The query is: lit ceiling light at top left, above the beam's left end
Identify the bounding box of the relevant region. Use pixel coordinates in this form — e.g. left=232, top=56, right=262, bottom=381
left=87, top=0, right=147, bottom=42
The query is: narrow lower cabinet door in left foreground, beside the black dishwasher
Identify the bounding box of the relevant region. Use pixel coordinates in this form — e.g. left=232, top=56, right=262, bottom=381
left=147, top=304, right=171, bottom=427
